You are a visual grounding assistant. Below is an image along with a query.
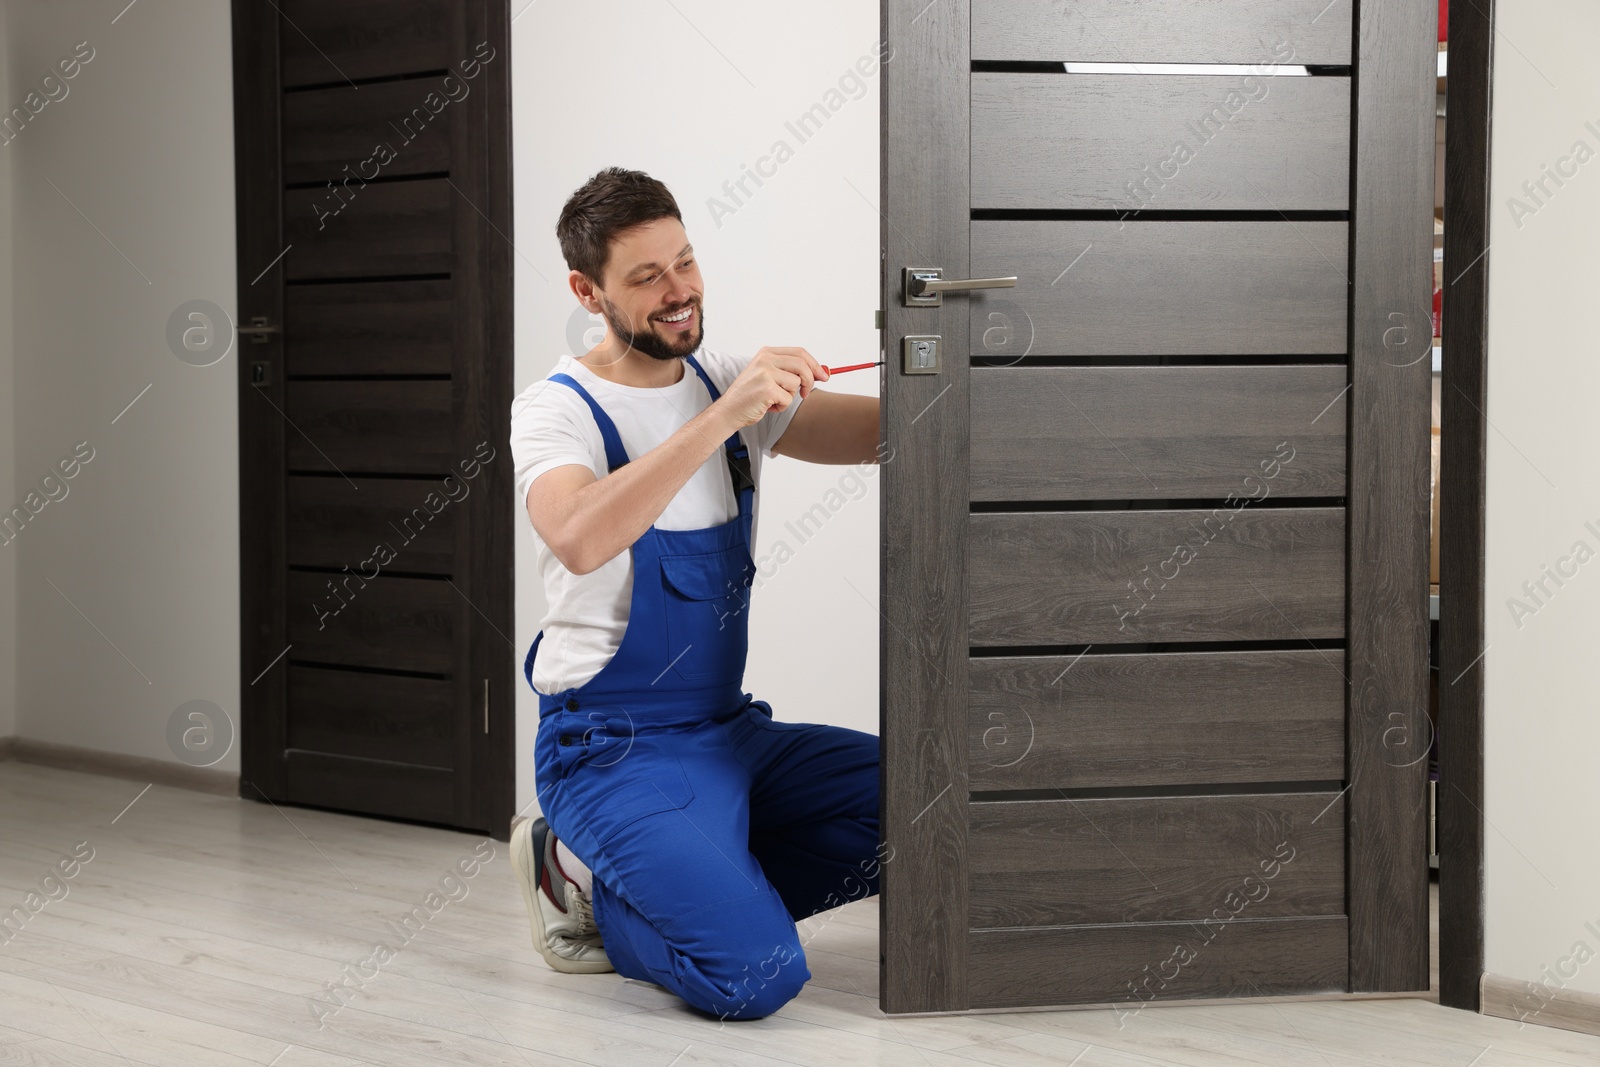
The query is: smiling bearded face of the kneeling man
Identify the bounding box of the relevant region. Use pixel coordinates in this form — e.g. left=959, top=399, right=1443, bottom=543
left=573, top=218, right=706, bottom=360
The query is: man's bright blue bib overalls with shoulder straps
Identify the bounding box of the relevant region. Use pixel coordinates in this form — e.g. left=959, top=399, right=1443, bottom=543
left=523, top=357, right=883, bottom=1019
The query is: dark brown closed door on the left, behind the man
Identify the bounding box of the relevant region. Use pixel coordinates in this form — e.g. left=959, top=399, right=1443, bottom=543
left=234, top=0, right=515, bottom=835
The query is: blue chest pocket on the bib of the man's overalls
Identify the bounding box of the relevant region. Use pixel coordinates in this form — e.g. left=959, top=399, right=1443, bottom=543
left=661, top=544, right=755, bottom=683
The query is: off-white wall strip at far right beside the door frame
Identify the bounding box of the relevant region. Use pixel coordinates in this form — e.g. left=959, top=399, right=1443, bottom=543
left=1478, top=0, right=1600, bottom=1011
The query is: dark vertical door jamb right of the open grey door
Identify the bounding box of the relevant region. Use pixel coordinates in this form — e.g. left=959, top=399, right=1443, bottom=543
left=1438, top=0, right=1496, bottom=1011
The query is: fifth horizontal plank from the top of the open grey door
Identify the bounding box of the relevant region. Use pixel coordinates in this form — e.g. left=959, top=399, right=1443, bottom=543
left=968, top=504, right=1344, bottom=646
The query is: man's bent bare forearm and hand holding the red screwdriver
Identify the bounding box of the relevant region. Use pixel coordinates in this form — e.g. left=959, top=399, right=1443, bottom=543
left=528, top=349, right=821, bottom=574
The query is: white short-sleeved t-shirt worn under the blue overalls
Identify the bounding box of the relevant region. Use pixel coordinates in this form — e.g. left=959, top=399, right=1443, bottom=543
left=510, top=349, right=800, bottom=693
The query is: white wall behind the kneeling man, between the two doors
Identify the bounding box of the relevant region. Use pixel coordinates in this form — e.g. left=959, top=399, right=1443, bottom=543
left=507, top=0, right=878, bottom=806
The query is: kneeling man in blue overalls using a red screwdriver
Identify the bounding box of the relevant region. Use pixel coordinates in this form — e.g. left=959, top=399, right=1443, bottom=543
left=512, top=168, right=878, bottom=1019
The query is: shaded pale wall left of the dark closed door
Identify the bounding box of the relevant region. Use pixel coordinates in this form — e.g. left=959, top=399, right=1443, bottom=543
left=0, top=0, right=240, bottom=771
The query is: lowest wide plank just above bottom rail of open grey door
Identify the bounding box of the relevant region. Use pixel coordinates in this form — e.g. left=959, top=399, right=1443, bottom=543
left=966, top=792, right=1344, bottom=927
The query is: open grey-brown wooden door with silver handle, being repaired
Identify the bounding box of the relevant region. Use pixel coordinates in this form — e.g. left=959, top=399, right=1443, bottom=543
left=882, top=0, right=1435, bottom=1013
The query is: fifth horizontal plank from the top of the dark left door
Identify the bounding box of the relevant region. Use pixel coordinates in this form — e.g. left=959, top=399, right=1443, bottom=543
left=285, top=381, right=457, bottom=477
